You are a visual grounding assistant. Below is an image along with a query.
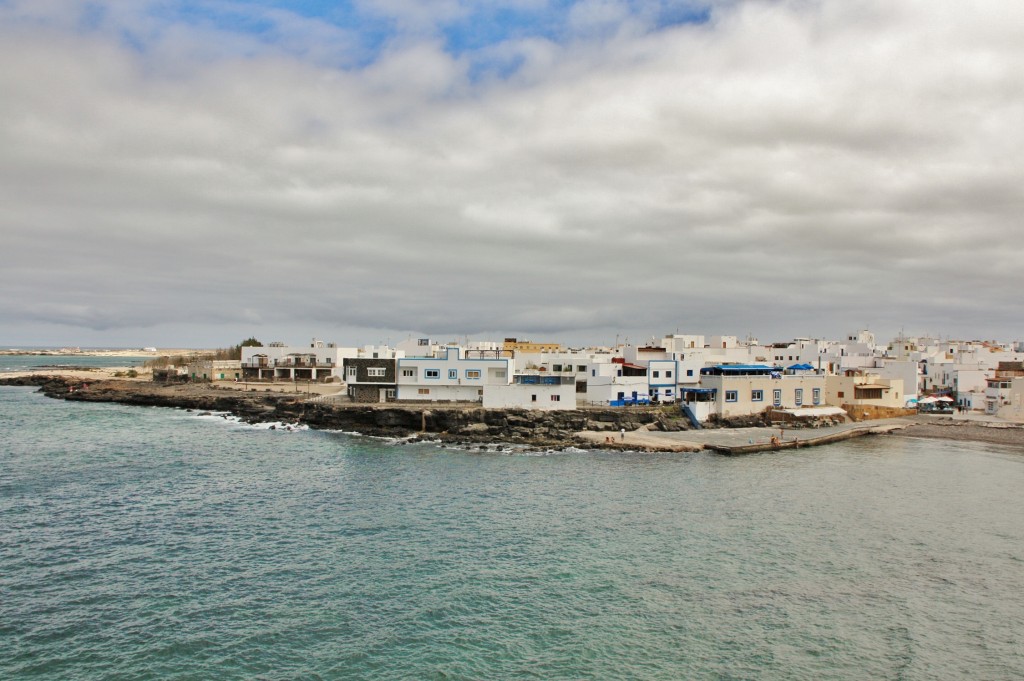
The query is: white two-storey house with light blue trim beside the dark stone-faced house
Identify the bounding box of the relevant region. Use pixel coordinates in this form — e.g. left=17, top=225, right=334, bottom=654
left=395, top=346, right=512, bottom=402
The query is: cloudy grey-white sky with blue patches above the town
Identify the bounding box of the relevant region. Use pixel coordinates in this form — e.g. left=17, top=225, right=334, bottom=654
left=0, top=0, right=1024, bottom=347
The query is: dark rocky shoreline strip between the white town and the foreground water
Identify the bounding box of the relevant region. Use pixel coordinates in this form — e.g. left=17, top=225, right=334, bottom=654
left=8, top=374, right=1024, bottom=455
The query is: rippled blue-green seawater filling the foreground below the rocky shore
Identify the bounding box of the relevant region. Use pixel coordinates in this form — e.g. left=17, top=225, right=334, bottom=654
left=0, top=388, right=1024, bottom=680
